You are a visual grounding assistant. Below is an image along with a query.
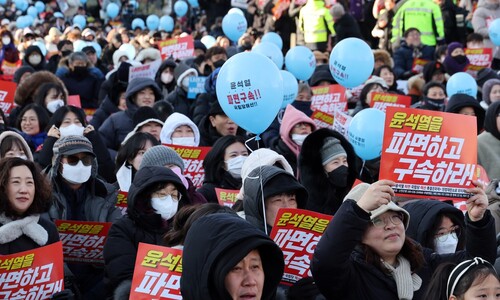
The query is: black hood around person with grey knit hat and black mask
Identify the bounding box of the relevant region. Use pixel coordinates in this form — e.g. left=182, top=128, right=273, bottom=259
left=299, top=128, right=357, bottom=215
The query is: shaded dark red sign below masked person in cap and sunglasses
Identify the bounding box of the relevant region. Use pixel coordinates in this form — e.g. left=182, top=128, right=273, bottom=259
left=55, top=220, right=111, bottom=264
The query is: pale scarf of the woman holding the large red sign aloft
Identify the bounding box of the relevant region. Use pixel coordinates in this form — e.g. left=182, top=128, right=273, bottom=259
left=382, top=255, right=422, bottom=300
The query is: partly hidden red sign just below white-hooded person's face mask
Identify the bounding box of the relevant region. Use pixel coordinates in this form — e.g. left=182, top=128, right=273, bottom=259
left=165, top=145, right=212, bottom=188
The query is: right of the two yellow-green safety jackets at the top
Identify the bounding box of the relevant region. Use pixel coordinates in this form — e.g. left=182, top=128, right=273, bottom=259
left=391, top=0, right=444, bottom=48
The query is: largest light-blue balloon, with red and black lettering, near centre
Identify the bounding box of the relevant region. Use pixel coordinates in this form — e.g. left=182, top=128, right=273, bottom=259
left=215, top=52, right=283, bottom=135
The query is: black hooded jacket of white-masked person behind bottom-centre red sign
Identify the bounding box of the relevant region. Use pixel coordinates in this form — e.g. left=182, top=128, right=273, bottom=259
left=104, top=166, right=189, bottom=299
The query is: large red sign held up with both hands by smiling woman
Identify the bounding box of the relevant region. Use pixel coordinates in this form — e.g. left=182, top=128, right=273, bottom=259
left=380, top=107, right=477, bottom=199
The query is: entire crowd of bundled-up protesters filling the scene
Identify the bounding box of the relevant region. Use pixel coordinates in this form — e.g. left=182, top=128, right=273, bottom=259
left=0, top=0, right=500, bottom=300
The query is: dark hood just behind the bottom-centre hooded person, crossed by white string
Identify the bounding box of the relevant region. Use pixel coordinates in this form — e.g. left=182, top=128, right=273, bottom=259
left=243, top=166, right=307, bottom=234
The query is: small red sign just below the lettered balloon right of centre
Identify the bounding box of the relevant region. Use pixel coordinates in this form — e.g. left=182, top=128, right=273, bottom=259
left=311, top=84, right=347, bottom=115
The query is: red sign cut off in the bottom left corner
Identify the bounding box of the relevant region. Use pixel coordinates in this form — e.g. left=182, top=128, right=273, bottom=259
left=0, top=242, right=64, bottom=300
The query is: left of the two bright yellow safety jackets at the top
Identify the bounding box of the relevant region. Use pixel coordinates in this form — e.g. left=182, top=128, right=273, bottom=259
left=299, top=0, right=335, bottom=52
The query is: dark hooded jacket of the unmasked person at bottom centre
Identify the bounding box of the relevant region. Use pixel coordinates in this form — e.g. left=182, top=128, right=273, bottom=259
left=181, top=214, right=284, bottom=300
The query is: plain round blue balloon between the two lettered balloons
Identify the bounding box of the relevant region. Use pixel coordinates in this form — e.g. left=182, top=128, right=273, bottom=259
left=285, top=46, right=316, bottom=80
